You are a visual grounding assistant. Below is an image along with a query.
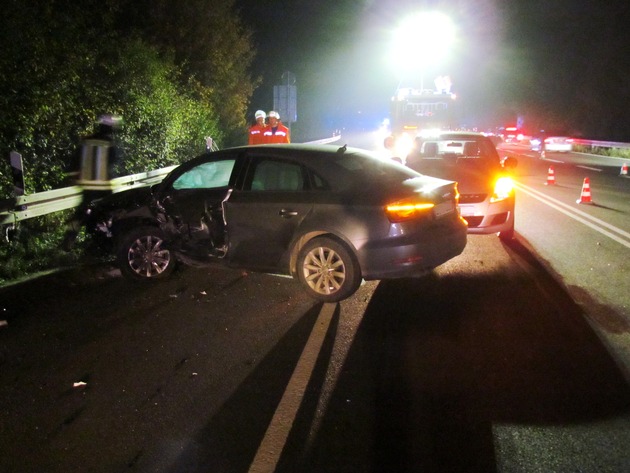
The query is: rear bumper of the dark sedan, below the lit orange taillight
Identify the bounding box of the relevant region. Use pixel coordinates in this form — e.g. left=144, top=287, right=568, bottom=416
left=358, top=217, right=467, bottom=280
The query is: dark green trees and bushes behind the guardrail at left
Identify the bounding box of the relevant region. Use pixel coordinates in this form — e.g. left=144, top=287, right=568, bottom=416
left=0, top=0, right=259, bottom=195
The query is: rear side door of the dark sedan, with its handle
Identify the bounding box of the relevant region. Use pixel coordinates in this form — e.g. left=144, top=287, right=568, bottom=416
left=224, top=156, right=313, bottom=271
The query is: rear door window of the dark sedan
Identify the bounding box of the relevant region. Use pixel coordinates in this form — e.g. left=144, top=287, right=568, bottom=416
left=251, top=159, right=304, bottom=192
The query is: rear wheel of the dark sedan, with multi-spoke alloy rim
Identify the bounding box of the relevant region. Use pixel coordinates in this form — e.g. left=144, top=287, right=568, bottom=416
left=297, top=237, right=361, bottom=302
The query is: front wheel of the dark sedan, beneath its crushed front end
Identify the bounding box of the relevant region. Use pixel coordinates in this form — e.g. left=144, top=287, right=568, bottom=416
left=116, top=227, right=176, bottom=281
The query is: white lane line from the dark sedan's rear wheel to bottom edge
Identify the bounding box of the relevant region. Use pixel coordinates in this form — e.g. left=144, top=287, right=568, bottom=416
left=249, top=303, right=337, bottom=473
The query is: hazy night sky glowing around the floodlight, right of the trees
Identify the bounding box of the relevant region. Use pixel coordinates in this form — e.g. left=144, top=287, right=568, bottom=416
left=236, top=0, right=630, bottom=142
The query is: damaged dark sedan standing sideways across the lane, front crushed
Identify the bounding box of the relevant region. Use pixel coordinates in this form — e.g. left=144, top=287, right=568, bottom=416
left=82, top=145, right=467, bottom=302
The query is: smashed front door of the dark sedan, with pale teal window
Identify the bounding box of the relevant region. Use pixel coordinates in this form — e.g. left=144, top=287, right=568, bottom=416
left=160, top=156, right=236, bottom=257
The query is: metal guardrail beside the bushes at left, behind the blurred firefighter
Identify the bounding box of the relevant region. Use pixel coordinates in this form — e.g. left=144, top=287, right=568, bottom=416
left=0, top=166, right=176, bottom=225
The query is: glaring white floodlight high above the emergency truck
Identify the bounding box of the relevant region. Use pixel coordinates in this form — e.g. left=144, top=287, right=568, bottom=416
left=392, top=12, right=455, bottom=69
